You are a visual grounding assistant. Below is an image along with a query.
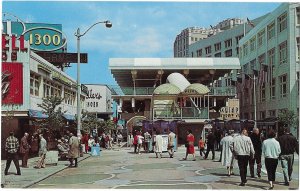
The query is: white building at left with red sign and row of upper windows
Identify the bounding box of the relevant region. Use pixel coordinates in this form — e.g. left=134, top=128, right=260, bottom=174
left=1, top=18, right=87, bottom=155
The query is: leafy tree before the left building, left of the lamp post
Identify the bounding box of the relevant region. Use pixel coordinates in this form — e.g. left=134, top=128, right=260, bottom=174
left=36, top=96, right=65, bottom=131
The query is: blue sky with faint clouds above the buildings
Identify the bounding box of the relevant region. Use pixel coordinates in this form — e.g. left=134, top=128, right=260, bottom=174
left=2, top=1, right=280, bottom=85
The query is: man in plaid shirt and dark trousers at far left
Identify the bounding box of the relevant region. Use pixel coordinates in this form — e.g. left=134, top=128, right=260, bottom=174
left=4, top=132, right=21, bottom=175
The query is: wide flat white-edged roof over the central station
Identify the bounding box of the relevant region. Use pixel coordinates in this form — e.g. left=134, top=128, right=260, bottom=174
left=109, top=57, right=241, bottom=87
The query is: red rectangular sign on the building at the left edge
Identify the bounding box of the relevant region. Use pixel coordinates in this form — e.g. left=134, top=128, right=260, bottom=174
left=2, top=62, right=23, bottom=104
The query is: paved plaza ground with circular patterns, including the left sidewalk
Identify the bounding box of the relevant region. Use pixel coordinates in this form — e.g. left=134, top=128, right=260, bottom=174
left=2, top=147, right=299, bottom=190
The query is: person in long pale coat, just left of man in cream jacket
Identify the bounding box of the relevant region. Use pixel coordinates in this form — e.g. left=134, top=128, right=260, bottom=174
left=220, top=131, right=235, bottom=176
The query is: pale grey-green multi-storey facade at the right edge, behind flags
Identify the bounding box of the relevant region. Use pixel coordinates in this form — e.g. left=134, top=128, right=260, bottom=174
left=239, top=3, right=300, bottom=134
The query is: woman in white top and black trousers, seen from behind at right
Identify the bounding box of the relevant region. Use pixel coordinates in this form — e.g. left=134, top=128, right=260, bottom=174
left=262, top=129, right=281, bottom=190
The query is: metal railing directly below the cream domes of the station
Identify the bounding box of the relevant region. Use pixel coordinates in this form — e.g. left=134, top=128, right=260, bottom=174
left=153, top=105, right=208, bottom=119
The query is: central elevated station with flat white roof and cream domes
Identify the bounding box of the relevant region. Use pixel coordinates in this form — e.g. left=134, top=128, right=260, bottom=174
left=109, top=58, right=240, bottom=144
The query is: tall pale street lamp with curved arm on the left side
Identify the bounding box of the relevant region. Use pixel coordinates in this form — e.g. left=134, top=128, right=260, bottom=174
left=75, top=21, right=112, bottom=137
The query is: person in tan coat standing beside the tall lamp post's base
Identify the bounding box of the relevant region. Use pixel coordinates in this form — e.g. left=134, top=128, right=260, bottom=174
left=68, top=133, right=80, bottom=167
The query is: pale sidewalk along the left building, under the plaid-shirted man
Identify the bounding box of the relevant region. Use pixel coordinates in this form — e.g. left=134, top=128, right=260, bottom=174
left=1, top=154, right=90, bottom=188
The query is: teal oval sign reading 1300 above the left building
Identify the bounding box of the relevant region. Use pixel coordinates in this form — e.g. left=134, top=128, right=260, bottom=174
left=23, top=27, right=67, bottom=51
